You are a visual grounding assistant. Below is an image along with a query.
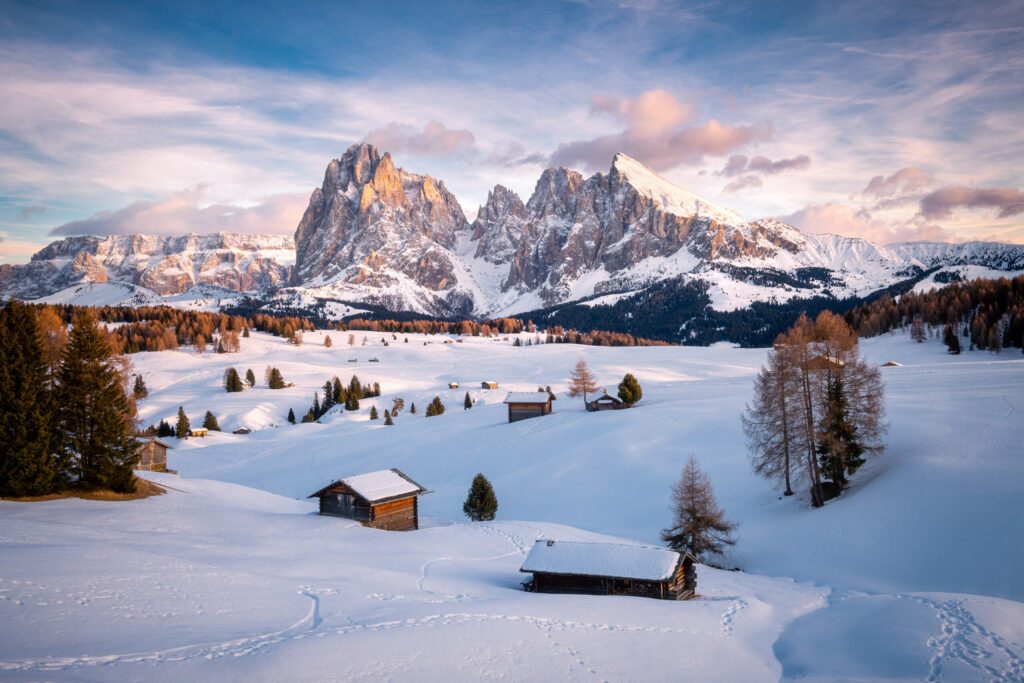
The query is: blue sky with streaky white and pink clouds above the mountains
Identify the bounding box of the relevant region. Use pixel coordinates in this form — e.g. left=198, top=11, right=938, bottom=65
left=0, top=0, right=1024, bottom=263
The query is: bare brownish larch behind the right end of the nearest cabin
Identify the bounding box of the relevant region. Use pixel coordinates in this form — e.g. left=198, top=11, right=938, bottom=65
left=662, top=456, right=736, bottom=560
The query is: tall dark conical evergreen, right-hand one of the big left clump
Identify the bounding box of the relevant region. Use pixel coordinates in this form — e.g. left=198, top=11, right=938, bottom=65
left=59, top=313, right=138, bottom=493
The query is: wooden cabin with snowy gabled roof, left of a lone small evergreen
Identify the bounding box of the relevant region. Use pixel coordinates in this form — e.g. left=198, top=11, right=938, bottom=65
left=309, top=468, right=427, bottom=531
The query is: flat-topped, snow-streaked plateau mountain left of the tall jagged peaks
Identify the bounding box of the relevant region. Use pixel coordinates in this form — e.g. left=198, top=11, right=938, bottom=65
left=0, top=232, right=295, bottom=299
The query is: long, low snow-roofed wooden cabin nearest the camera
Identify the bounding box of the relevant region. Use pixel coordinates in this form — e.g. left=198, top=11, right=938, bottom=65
left=520, top=541, right=697, bottom=600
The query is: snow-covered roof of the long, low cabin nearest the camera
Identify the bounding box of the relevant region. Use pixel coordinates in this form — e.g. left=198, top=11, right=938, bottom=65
left=520, top=540, right=681, bottom=581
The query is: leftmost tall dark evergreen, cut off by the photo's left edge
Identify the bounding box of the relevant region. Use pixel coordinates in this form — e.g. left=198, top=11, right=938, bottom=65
left=0, top=300, right=63, bottom=497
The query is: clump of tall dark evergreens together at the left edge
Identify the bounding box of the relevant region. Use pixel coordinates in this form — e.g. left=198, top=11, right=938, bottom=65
left=0, top=301, right=138, bottom=497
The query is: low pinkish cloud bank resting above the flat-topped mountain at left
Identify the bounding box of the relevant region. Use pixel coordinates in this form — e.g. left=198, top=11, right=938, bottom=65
left=50, top=185, right=309, bottom=236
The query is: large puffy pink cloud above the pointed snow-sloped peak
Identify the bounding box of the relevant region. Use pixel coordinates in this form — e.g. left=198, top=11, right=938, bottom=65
left=551, top=90, right=774, bottom=171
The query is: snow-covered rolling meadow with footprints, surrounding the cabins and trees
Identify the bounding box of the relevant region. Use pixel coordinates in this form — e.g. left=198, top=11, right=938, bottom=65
left=0, top=332, right=1024, bottom=680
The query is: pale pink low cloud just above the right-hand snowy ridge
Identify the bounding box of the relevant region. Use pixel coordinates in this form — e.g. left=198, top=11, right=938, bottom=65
left=780, top=202, right=951, bottom=245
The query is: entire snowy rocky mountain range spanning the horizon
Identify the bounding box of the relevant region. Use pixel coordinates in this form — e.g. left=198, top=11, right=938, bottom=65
left=6, top=144, right=1024, bottom=316
